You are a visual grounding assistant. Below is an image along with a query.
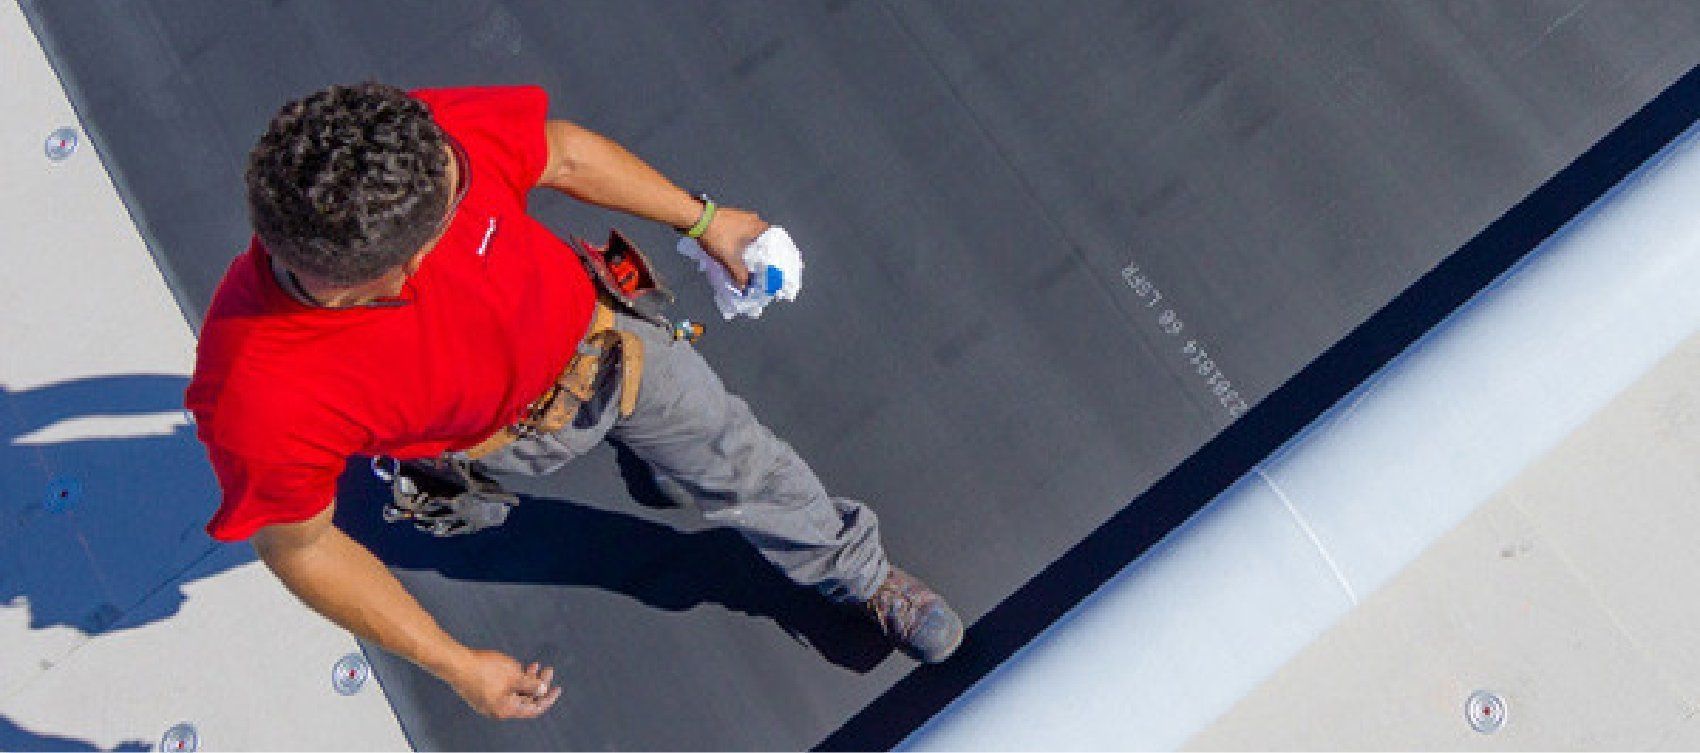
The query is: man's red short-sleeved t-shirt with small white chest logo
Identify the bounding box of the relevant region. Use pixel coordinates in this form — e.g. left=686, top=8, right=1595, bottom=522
left=187, top=87, right=595, bottom=541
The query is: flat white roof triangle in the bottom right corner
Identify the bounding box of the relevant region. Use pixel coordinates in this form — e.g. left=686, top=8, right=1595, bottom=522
left=1188, top=337, right=1700, bottom=750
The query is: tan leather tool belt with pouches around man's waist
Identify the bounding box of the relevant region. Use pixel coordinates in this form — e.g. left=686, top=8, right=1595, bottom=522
left=372, top=231, right=676, bottom=535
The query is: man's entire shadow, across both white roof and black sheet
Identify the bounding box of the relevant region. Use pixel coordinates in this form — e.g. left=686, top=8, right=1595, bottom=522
left=0, top=374, right=889, bottom=671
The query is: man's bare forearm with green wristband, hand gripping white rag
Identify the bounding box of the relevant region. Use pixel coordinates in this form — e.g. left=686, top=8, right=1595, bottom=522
left=537, top=121, right=767, bottom=286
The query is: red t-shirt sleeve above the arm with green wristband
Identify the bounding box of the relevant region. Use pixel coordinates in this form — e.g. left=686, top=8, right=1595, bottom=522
left=411, top=87, right=549, bottom=197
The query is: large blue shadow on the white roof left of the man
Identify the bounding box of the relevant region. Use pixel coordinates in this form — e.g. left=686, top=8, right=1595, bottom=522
left=0, top=374, right=253, bottom=636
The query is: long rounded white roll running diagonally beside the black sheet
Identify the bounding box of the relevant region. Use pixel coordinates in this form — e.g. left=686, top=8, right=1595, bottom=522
left=906, top=100, right=1700, bottom=750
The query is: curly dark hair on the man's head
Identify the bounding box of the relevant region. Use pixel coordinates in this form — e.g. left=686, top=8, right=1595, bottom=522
left=247, top=83, right=449, bottom=286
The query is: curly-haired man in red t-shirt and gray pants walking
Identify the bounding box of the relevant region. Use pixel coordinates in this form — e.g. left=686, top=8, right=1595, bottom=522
left=187, top=83, right=962, bottom=719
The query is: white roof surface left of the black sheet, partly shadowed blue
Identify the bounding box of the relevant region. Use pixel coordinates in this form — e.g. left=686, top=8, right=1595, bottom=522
left=0, top=3, right=406, bottom=750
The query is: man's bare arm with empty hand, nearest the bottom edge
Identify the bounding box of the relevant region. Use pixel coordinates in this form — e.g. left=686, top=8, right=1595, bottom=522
left=253, top=503, right=561, bottom=719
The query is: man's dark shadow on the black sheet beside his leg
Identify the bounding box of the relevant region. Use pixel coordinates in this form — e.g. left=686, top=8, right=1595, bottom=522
left=335, top=445, right=893, bottom=673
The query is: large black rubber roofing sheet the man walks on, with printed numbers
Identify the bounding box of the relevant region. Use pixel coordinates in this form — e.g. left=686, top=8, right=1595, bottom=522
left=24, top=0, right=1700, bottom=750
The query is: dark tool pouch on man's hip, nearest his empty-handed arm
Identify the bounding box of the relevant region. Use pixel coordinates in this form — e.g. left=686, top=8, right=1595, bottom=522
left=372, top=457, right=520, bottom=535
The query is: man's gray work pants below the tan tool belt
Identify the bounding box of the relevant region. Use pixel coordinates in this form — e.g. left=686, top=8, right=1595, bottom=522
left=481, top=314, right=889, bottom=602
